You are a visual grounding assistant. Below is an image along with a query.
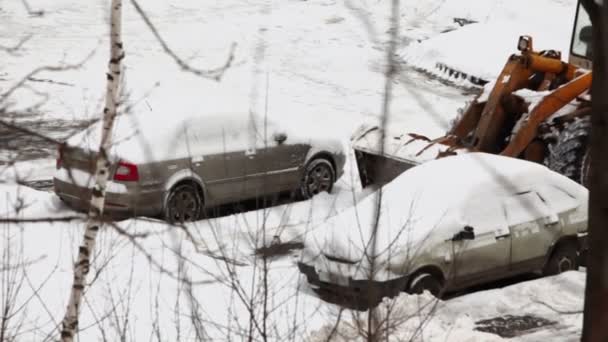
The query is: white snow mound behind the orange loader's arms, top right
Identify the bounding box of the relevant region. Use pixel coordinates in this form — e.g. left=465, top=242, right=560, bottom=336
left=401, top=0, right=576, bottom=80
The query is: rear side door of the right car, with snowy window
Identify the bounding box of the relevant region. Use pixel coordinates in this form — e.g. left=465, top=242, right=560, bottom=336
left=504, top=190, right=572, bottom=272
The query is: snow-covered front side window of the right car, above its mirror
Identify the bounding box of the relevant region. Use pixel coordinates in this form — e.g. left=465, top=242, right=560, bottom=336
left=464, top=197, right=509, bottom=236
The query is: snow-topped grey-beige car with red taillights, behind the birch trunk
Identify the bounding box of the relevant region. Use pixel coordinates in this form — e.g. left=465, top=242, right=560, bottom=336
left=54, top=107, right=345, bottom=222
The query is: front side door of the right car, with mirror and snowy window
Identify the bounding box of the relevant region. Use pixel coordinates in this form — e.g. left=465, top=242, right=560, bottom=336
left=452, top=196, right=511, bottom=287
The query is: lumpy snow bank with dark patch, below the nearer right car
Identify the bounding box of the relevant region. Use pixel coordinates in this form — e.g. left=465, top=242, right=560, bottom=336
left=309, top=271, right=585, bottom=342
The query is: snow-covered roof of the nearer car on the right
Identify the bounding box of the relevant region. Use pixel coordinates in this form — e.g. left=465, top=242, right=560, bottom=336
left=384, top=152, right=586, bottom=209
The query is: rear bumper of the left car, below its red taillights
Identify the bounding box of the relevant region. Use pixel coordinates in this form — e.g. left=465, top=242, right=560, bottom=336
left=53, top=178, right=162, bottom=217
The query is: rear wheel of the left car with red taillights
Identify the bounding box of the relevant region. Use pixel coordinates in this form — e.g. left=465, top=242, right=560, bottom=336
left=165, top=183, right=203, bottom=223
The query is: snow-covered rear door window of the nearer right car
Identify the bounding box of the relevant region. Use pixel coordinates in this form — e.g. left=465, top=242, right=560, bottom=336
left=503, top=191, right=552, bottom=226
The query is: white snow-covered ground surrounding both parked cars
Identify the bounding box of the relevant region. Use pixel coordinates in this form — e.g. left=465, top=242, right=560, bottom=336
left=0, top=0, right=584, bottom=341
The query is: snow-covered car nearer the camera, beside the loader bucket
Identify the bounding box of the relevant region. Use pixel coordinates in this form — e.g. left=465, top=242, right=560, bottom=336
left=298, top=153, right=588, bottom=308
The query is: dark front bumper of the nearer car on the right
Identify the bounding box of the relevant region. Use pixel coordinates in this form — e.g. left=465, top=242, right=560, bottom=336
left=298, top=262, right=408, bottom=310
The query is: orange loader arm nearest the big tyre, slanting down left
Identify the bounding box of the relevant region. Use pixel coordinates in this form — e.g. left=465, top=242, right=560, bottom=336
left=500, top=72, right=592, bottom=157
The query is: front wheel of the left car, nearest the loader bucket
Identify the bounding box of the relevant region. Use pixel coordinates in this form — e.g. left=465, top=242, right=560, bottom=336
left=300, top=158, right=336, bottom=199
